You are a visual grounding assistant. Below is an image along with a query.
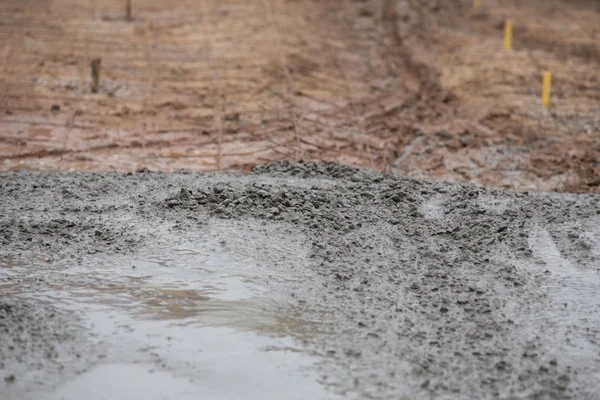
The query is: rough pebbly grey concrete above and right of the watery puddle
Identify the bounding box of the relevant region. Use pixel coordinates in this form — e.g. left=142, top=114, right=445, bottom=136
left=0, top=163, right=600, bottom=399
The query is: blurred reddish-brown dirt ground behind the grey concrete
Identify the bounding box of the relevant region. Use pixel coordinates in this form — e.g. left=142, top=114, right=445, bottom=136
left=0, top=0, right=600, bottom=193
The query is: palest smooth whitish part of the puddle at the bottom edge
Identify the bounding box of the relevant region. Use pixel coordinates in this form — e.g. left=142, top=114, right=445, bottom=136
left=50, top=324, right=334, bottom=400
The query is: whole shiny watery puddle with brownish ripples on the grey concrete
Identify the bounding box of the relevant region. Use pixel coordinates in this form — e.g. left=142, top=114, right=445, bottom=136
left=0, top=225, right=337, bottom=400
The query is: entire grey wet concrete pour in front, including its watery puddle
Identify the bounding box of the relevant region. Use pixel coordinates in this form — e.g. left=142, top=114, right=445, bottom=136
left=0, top=163, right=600, bottom=399
